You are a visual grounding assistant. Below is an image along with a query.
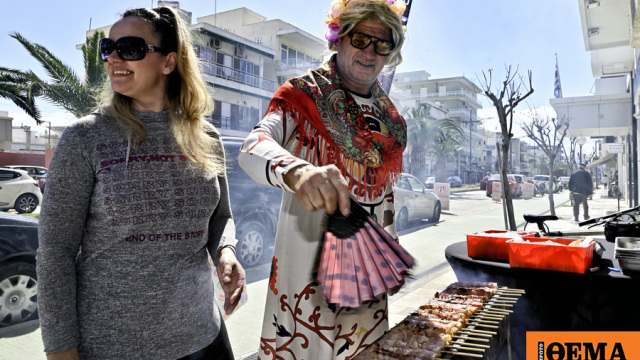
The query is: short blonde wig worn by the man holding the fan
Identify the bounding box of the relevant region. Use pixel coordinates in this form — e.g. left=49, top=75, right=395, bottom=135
left=329, top=0, right=404, bottom=67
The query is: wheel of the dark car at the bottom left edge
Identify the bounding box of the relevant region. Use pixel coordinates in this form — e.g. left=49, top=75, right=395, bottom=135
left=0, top=263, right=38, bottom=327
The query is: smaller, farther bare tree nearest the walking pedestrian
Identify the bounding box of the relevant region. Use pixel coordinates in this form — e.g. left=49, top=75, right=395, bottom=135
left=522, top=110, right=569, bottom=215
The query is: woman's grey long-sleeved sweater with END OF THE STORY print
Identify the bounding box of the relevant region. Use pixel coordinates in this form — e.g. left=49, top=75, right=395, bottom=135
left=37, top=112, right=235, bottom=359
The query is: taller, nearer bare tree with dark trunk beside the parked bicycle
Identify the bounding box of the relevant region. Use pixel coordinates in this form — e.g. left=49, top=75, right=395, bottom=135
left=481, top=66, right=533, bottom=230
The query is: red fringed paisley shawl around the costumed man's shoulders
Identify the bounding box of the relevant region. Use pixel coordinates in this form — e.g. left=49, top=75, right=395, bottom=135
left=268, top=55, right=407, bottom=199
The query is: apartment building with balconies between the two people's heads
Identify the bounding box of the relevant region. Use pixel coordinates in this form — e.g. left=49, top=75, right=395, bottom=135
left=87, top=1, right=329, bottom=137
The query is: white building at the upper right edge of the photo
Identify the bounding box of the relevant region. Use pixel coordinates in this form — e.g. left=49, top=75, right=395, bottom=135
left=550, top=0, right=640, bottom=206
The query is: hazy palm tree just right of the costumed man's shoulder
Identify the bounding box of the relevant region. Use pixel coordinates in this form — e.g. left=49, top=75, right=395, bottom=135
left=403, top=105, right=462, bottom=181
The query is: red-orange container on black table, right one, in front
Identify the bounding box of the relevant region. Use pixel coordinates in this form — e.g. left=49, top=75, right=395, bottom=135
left=508, top=237, right=594, bottom=274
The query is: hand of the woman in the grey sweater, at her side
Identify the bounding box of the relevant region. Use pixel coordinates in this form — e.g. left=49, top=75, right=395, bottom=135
left=216, top=248, right=246, bottom=315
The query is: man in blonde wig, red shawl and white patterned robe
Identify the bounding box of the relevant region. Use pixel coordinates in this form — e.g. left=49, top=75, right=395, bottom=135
left=238, top=0, right=407, bottom=360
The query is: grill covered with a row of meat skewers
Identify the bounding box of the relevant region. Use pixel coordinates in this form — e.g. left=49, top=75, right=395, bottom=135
left=354, top=282, right=524, bottom=360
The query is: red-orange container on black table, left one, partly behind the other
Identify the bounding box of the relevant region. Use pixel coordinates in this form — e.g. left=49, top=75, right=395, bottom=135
left=467, top=230, right=536, bottom=261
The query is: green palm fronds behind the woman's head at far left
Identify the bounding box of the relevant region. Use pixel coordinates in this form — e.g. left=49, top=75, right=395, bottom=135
left=0, top=31, right=106, bottom=123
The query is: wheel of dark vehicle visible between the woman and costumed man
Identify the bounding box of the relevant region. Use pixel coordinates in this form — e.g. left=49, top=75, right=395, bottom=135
left=236, top=221, right=268, bottom=268
